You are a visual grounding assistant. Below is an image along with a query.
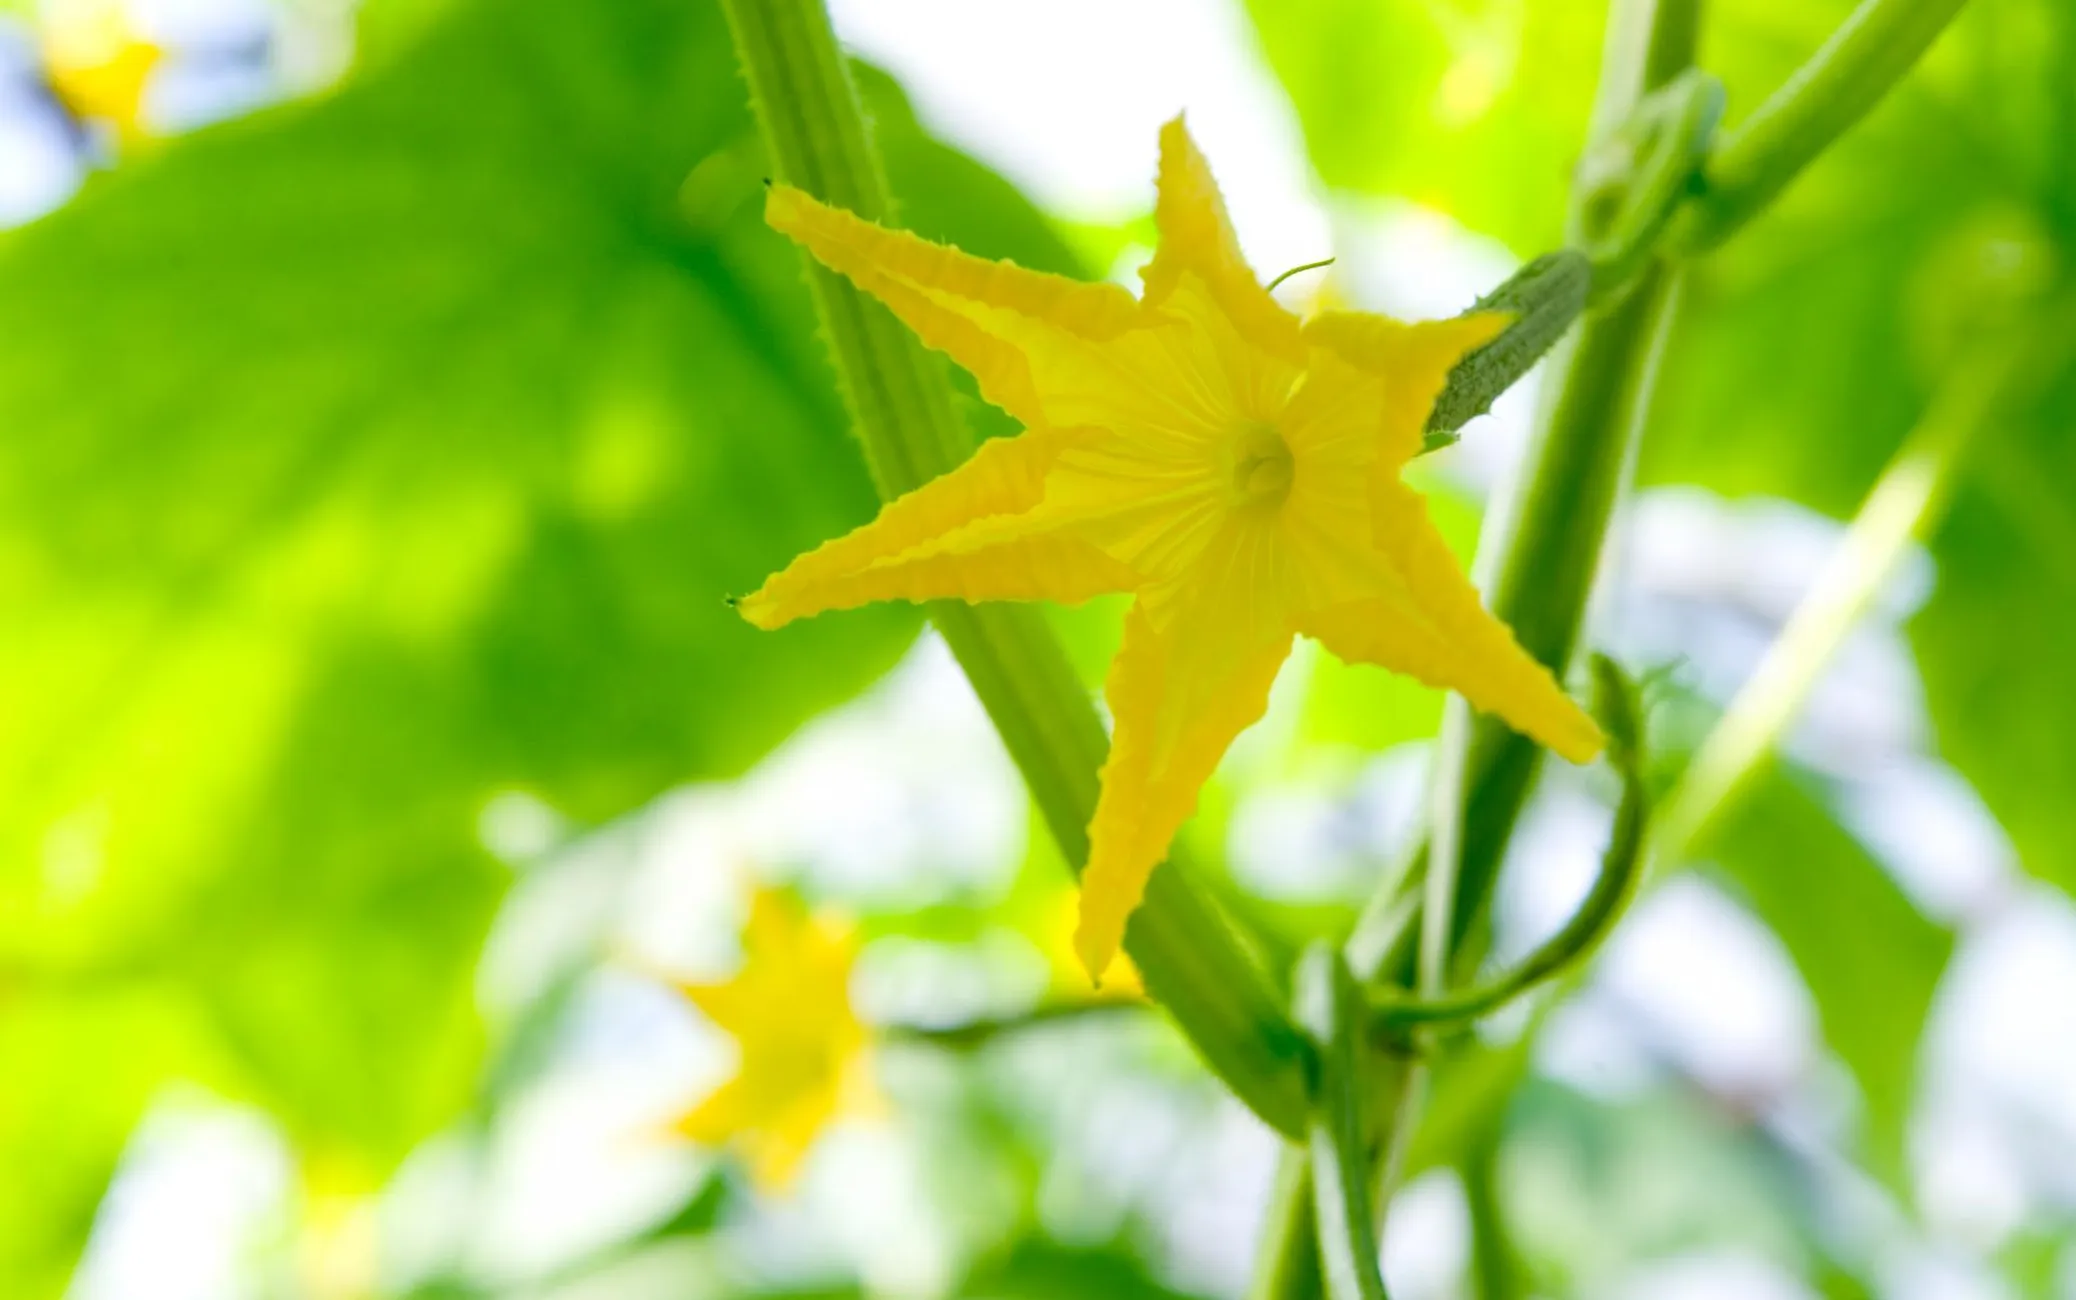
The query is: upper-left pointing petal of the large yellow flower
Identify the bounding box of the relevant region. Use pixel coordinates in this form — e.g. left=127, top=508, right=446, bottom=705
left=764, top=185, right=1146, bottom=426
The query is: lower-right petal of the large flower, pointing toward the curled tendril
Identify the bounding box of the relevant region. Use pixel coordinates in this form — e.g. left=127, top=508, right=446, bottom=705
left=1295, top=475, right=1605, bottom=762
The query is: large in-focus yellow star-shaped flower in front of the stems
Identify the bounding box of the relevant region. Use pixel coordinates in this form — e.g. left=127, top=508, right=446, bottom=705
left=741, top=118, right=1601, bottom=978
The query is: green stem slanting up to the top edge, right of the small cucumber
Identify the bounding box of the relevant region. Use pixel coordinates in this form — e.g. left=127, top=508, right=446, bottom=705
left=1673, top=0, right=1968, bottom=253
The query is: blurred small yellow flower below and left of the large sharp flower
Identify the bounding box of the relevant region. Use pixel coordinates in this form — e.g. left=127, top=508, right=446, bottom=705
left=675, top=889, right=870, bottom=1190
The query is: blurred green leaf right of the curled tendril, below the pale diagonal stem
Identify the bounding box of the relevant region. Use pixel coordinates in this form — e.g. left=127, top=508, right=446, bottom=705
left=1700, top=768, right=1954, bottom=1182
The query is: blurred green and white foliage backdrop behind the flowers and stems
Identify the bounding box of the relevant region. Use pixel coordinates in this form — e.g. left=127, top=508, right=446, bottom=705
left=0, top=0, right=2076, bottom=1300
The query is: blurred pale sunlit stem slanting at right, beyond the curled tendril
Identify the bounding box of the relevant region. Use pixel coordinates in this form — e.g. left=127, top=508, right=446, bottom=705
left=1650, top=326, right=2042, bottom=866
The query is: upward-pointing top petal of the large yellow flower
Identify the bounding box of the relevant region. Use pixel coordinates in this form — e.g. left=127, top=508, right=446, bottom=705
left=1140, top=116, right=1304, bottom=365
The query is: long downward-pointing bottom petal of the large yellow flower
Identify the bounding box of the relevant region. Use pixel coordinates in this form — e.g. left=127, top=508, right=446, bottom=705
left=1073, top=602, right=1289, bottom=982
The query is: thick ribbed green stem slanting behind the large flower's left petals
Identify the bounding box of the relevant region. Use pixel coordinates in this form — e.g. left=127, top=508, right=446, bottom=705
left=727, top=0, right=1310, bottom=1138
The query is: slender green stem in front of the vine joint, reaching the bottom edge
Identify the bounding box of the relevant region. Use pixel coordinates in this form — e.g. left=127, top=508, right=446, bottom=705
left=1295, top=943, right=1387, bottom=1300
